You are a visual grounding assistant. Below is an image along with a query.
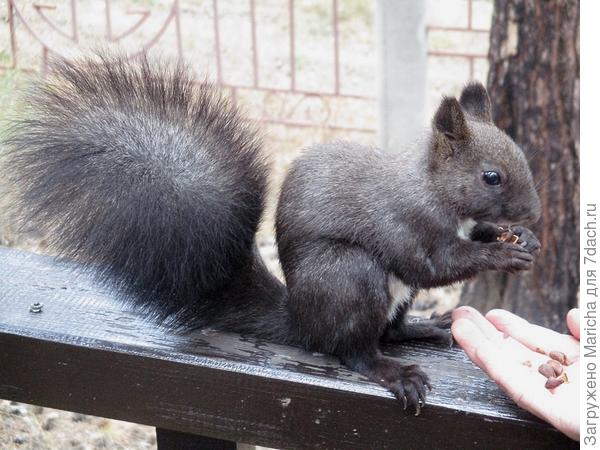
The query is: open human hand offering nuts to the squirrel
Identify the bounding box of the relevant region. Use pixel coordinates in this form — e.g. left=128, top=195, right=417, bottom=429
left=452, top=306, right=579, bottom=440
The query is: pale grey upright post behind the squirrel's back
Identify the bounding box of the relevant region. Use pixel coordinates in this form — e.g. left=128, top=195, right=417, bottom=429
left=376, top=0, right=427, bottom=152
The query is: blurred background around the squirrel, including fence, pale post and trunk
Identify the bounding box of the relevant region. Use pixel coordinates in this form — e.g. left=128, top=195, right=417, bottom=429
left=0, top=0, right=579, bottom=449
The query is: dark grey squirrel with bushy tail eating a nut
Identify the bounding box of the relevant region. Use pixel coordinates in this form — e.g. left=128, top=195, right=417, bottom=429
left=3, top=55, right=540, bottom=414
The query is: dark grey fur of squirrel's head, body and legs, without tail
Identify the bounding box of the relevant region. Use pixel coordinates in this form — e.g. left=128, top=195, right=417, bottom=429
left=277, top=81, right=540, bottom=411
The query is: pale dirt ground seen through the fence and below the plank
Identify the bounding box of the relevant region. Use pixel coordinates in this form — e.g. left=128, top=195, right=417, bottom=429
left=0, top=0, right=491, bottom=450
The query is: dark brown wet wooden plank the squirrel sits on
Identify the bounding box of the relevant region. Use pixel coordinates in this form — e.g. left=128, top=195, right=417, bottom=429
left=0, top=248, right=576, bottom=449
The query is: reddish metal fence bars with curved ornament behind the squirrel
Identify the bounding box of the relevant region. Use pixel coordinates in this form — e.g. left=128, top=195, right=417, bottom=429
left=0, top=0, right=489, bottom=132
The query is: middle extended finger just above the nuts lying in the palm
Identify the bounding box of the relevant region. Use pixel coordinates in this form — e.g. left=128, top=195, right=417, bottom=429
left=486, top=309, right=579, bottom=361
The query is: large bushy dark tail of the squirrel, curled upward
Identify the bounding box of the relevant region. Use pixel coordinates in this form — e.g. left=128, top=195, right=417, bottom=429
left=4, top=56, right=278, bottom=326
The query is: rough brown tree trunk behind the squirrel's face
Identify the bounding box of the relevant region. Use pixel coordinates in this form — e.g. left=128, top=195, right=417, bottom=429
left=461, top=0, right=579, bottom=330
